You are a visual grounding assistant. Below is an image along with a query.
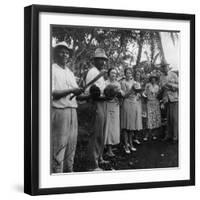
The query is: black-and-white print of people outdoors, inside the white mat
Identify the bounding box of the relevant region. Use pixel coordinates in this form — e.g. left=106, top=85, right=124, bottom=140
left=50, top=24, right=181, bottom=174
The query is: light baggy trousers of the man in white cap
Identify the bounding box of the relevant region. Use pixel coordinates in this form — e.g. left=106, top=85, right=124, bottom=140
left=51, top=108, right=78, bottom=173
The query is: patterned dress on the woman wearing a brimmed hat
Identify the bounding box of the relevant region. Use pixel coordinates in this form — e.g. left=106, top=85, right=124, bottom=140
left=145, top=83, right=161, bottom=129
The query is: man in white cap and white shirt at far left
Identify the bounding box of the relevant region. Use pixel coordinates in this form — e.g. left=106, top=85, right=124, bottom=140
left=51, top=42, right=82, bottom=173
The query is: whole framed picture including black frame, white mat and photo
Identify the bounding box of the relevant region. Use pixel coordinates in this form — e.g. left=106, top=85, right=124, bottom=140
left=24, top=5, right=195, bottom=195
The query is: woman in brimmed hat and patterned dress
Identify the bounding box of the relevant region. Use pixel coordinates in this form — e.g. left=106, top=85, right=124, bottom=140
left=144, top=74, right=161, bottom=140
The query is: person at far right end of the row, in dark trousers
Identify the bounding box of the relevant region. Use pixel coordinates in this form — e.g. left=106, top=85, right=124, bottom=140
left=160, top=63, right=178, bottom=142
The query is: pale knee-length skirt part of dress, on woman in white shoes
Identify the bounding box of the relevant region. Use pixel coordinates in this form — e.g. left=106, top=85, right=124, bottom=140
left=121, top=99, right=142, bottom=130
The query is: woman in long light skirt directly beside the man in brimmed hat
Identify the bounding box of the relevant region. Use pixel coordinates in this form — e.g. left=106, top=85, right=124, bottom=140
left=105, top=68, right=122, bottom=157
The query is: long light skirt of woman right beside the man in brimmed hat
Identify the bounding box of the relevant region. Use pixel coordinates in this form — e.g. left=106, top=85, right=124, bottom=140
left=105, top=102, right=120, bottom=145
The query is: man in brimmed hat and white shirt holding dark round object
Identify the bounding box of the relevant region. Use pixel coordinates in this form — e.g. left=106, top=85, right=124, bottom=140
left=86, top=48, right=108, bottom=171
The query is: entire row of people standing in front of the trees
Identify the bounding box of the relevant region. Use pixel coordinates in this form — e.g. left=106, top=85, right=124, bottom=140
left=51, top=43, right=178, bottom=173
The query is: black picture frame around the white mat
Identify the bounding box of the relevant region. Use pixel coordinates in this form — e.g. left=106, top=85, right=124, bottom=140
left=24, top=5, right=195, bottom=195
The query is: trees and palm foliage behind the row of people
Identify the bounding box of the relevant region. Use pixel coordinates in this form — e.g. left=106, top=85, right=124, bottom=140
left=52, top=25, right=179, bottom=82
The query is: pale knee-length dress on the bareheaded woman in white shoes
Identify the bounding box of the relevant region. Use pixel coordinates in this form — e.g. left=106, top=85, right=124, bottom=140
left=121, top=79, right=142, bottom=130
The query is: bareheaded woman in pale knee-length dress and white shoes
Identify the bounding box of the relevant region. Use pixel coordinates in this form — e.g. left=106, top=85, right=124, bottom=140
left=121, top=68, right=142, bottom=154
